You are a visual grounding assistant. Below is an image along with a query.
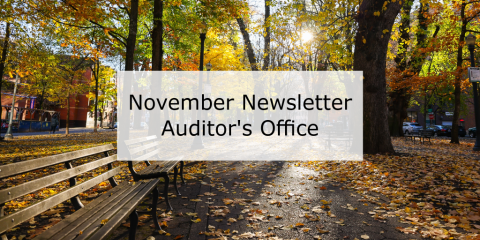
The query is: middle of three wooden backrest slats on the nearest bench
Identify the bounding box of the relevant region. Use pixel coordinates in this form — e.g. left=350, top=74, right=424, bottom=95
left=0, top=155, right=117, bottom=203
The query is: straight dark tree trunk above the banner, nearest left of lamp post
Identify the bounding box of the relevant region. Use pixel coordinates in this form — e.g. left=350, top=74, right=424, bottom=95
left=148, top=0, right=163, bottom=138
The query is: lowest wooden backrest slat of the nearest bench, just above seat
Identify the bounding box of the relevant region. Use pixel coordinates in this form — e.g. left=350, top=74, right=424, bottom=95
left=0, top=167, right=122, bottom=233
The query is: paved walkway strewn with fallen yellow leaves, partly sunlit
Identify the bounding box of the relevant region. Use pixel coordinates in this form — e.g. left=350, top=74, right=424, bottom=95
left=109, top=161, right=420, bottom=240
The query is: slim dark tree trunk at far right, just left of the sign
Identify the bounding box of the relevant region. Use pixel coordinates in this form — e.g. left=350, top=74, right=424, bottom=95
left=450, top=2, right=468, bottom=143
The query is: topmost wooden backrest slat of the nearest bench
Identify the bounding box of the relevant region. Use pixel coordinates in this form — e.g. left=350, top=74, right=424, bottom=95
left=0, top=144, right=114, bottom=178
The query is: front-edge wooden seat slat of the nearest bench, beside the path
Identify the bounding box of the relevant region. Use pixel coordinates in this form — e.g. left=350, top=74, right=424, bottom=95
left=87, top=179, right=160, bottom=240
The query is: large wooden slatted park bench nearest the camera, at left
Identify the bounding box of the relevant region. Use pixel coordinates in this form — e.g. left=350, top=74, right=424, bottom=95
left=0, top=144, right=160, bottom=239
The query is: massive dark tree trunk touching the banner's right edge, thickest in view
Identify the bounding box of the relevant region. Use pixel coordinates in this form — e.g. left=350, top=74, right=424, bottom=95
left=353, top=0, right=401, bottom=154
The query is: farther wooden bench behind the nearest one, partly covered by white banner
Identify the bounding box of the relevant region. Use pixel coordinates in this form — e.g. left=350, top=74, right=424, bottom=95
left=125, top=136, right=185, bottom=210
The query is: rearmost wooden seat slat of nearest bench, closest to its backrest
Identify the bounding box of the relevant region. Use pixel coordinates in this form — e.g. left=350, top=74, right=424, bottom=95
left=34, top=181, right=131, bottom=240
